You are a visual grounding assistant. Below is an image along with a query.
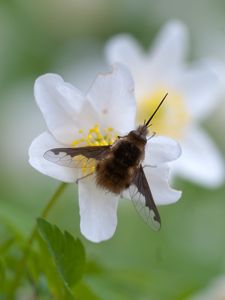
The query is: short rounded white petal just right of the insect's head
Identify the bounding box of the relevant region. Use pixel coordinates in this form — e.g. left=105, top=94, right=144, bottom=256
left=143, top=136, right=181, bottom=166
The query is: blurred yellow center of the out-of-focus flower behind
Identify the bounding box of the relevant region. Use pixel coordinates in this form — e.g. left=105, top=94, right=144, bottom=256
left=137, top=89, right=190, bottom=139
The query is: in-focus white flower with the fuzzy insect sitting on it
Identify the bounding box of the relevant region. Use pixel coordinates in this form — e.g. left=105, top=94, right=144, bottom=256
left=29, top=65, right=181, bottom=242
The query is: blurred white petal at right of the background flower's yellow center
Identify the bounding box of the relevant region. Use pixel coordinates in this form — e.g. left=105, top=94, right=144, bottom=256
left=176, top=65, right=220, bottom=120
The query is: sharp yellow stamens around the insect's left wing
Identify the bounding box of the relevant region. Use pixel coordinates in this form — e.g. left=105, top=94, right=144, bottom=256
left=71, top=124, right=117, bottom=175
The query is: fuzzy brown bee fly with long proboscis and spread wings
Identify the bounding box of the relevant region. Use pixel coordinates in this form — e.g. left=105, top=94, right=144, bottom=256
left=44, top=94, right=168, bottom=230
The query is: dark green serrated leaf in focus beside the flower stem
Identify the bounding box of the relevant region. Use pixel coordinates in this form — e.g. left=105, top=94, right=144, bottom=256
left=37, top=219, right=85, bottom=287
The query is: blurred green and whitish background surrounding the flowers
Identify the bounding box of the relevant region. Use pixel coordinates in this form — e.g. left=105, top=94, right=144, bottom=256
left=0, top=0, right=225, bottom=300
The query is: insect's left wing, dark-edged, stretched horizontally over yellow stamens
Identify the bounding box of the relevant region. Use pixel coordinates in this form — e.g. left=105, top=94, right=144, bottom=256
left=44, top=145, right=110, bottom=168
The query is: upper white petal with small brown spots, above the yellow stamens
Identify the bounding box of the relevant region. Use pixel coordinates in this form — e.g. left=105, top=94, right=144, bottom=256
left=87, top=65, right=136, bottom=134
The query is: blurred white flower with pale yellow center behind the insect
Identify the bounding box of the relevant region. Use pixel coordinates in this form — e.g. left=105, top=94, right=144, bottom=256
left=106, top=21, right=224, bottom=187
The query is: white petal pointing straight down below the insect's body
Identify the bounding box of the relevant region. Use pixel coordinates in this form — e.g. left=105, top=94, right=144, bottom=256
left=79, top=176, right=118, bottom=243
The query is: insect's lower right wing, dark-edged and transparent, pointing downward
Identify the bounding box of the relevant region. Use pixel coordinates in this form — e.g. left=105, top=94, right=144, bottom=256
left=129, top=165, right=161, bottom=231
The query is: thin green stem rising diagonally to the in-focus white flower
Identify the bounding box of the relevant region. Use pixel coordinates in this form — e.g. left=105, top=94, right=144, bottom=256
left=8, top=182, right=67, bottom=299
